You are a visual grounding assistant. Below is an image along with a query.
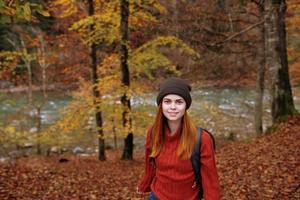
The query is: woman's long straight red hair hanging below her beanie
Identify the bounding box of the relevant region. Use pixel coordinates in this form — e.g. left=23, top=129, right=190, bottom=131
left=150, top=104, right=197, bottom=160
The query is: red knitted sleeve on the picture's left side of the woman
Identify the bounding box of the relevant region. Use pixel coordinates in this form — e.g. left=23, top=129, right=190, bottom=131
left=138, top=128, right=155, bottom=192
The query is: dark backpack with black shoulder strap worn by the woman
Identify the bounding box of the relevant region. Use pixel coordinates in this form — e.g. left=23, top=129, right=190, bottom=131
left=151, top=127, right=216, bottom=199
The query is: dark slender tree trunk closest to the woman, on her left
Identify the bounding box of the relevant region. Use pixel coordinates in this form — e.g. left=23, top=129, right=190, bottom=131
left=120, top=0, right=133, bottom=160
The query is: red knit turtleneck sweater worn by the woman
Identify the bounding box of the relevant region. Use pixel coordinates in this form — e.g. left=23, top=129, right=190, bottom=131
left=138, top=126, right=220, bottom=200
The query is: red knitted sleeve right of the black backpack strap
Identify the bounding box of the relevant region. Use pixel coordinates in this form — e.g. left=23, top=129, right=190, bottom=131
left=201, top=131, right=221, bottom=200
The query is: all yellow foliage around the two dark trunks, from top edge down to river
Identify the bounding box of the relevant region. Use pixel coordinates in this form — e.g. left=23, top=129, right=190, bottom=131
left=44, top=0, right=199, bottom=144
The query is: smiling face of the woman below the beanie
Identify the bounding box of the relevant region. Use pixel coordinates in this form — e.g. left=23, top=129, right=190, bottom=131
left=162, top=94, right=186, bottom=121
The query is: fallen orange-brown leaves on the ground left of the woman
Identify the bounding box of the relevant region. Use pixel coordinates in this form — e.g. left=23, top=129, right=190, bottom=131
left=0, top=152, right=142, bottom=200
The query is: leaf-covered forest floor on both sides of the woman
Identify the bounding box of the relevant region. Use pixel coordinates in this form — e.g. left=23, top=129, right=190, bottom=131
left=0, top=116, right=300, bottom=200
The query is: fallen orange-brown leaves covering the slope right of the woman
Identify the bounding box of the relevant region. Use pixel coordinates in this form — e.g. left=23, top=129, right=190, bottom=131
left=217, top=116, right=300, bottom=199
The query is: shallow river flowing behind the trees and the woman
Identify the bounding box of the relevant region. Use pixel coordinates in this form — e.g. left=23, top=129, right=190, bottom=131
left=0, top=87, right=300, bottom=153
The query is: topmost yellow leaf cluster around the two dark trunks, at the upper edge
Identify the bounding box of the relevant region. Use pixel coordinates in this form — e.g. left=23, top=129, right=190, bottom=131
left=67, top=0, right=165, bottom=45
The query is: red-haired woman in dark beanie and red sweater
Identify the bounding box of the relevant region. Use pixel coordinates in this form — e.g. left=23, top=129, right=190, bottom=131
left=137, top=78, right=220, bottom=200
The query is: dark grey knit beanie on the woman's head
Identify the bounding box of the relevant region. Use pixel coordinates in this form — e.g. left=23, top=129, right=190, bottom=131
left=156, top=77, right=192, bottom=109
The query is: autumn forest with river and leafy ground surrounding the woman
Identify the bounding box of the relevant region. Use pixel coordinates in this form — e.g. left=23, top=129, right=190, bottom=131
left=0, top=0, right=300, bottom=200
